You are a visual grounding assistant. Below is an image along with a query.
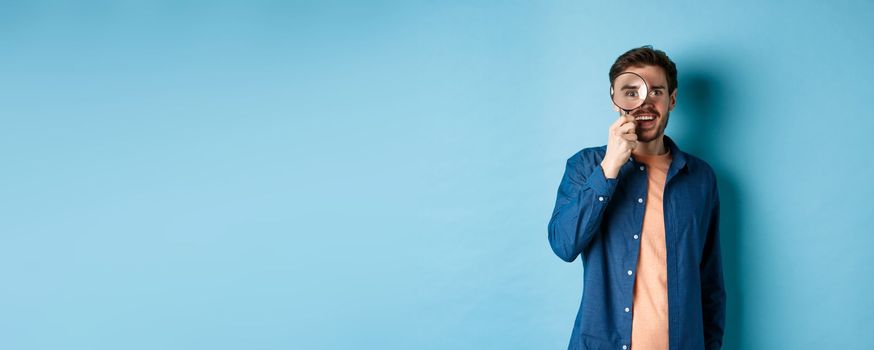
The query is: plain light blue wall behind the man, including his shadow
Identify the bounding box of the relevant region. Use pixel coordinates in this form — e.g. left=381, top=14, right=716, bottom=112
left=0, top=1, right=874, bottom=349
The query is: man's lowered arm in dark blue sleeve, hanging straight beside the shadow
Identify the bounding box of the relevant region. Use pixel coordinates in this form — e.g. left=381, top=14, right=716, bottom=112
left=701, top=185, right=725, bottom=350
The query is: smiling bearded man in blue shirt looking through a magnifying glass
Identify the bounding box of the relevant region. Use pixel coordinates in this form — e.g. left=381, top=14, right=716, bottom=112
left=549, top=46, right=725, bottom=350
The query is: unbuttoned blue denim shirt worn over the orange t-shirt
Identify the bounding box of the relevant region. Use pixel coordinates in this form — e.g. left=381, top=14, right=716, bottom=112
left=549, top=136, right=725, bottom=350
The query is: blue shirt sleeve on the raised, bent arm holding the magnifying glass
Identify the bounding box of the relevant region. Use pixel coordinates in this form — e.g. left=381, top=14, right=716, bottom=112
left=549, top=152, right=616, bottom=262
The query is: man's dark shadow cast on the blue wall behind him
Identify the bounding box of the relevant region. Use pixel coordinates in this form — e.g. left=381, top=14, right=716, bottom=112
left=677, top=65, right=746, bottom=350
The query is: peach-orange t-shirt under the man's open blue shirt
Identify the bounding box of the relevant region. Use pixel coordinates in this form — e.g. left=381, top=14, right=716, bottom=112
left=631, top=152, right=671, bottom=350
